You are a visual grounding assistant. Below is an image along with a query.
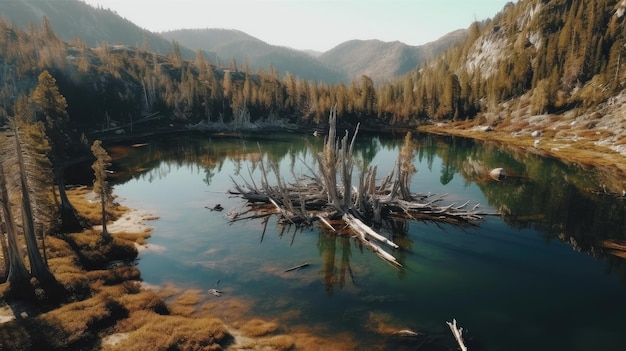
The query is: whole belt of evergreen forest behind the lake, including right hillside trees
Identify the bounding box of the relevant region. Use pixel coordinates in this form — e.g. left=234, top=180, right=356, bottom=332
left=0, top=0, right=626, bottom=136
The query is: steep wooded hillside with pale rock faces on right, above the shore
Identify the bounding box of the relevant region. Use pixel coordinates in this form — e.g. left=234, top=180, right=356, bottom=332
left=382, top=0, right=626, bottom=119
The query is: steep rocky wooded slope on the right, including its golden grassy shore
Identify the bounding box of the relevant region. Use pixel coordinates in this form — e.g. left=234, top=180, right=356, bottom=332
left=414, top=0, right=626, bottom=176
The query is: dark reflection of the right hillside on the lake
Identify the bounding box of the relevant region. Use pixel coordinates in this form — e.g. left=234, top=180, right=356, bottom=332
left=426, top=138, right=626, bottom=274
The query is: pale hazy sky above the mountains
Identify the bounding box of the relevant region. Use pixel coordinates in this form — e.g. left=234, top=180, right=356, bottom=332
left=83, top=0, right=517, bottom=51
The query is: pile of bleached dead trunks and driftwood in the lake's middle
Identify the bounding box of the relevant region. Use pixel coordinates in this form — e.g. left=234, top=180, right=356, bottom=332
left=231, top=108, right=493, bottom=267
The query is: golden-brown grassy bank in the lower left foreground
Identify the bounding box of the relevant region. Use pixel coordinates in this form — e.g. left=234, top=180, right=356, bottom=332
left=0, top=188, right=355, bottom=351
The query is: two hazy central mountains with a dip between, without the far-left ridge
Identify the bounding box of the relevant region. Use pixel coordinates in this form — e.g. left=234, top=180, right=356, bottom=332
left=161, top=29, right=467, bottom=83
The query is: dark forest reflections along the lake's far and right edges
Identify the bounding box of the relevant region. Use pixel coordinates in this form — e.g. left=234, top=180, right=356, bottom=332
left=102, top=133, right=626, bottom=269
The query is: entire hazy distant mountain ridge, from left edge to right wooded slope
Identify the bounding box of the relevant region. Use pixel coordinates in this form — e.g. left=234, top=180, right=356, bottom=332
left=0, top=0, right=464, bottom=84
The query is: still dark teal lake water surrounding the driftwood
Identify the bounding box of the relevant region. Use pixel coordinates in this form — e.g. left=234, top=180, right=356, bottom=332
left=97, top=133, right=626, bottom=351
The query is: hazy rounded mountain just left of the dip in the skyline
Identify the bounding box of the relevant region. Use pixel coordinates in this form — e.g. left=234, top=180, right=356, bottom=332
left=161, top=29, right=346, bottom=83
